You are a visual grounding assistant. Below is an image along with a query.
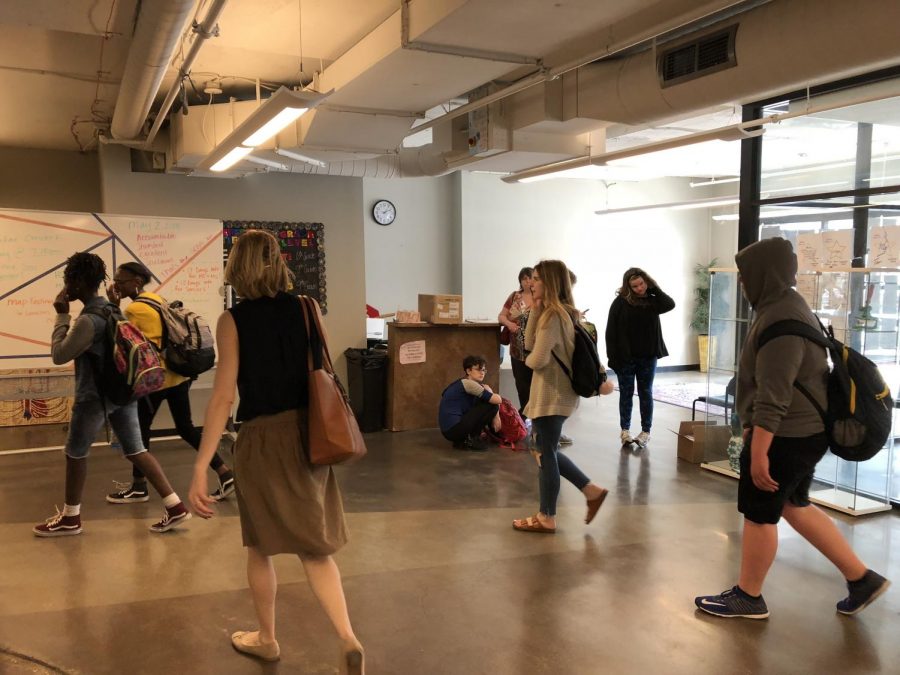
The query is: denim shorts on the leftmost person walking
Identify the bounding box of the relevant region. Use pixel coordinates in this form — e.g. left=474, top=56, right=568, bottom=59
left=66, top=398, right=147, bottom=459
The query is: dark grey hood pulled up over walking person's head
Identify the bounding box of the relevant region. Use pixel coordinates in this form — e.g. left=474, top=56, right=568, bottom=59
left=734, top=237, right=797, bottom=308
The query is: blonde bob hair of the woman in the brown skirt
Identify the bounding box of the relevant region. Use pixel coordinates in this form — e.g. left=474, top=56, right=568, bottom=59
left=225, top=230, right=294, bottom=300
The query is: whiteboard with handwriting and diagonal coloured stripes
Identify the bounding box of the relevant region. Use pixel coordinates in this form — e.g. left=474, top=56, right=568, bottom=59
left=0, top=209, right=224, bottom=370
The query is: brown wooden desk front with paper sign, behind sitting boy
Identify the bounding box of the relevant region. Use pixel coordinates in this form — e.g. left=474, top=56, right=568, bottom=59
left=386, top=322, right=500, bottom=431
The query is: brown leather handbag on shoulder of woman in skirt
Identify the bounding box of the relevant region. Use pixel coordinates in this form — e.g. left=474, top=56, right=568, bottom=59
left=300, top=295, right=366, bottom=464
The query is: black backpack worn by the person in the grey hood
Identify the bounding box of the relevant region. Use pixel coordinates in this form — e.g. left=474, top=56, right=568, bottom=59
left=758, top=319, right=894, bottom=462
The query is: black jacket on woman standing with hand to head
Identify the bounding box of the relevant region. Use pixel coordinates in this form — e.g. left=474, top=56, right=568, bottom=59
left=606, top=288, right=675, bottom=370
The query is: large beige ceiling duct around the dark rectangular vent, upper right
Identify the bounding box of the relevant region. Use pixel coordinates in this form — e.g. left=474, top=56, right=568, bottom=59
left=564, top=0, right=900, bottom=125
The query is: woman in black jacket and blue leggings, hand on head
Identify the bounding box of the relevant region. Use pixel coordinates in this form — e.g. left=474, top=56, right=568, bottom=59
left=606, top=267, right=675, bottom=448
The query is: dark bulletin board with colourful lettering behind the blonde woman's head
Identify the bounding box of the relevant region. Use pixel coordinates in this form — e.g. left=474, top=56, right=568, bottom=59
left=222, top=220, right=328, bottom=314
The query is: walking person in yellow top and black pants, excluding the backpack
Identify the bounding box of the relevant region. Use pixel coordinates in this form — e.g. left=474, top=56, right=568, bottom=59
left=106, top=262, right=234, bottom=504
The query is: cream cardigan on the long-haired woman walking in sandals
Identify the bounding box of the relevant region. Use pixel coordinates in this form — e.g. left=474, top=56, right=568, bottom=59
left=524, top=307, right=578, bottom=419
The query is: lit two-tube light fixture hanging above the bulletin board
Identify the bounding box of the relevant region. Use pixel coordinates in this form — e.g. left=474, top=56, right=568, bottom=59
left=197, top=87, right=331, bottom=172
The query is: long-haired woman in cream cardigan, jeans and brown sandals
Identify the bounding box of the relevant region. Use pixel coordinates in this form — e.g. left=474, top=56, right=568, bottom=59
left=513, top=260, right=608, bottom=534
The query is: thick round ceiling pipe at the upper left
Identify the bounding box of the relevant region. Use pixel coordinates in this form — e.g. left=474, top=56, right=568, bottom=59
left=110, top=0, right=194, bottom=141
